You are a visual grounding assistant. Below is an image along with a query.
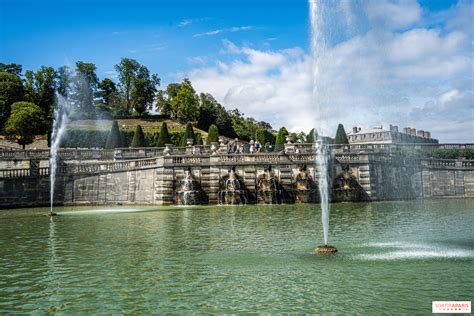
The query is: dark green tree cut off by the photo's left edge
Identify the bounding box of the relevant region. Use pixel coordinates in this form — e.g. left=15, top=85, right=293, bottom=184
left=0, top=72, right=23, bottom=131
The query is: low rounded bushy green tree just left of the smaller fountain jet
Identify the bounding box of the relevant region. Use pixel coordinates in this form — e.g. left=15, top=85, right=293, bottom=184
left=5, top=102, right=44, bottom=149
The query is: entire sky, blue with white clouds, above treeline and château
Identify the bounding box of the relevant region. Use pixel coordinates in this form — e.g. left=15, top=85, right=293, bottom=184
left=0, top=0, right=474, bottom=143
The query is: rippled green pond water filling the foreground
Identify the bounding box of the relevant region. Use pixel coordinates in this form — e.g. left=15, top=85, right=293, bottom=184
left=0, top=200, right=474, bottom=315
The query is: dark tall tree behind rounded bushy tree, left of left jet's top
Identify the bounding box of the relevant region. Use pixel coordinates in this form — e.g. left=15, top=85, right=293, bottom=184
left=25, top=66, right=58, bottom=125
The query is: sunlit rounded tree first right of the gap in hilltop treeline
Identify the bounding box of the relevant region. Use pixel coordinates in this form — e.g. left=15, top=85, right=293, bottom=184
left=171, top=79, right=199, bottom=122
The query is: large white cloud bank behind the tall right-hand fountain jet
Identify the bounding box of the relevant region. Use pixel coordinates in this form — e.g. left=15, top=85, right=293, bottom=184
left=181, top=0, right=474, bottom=142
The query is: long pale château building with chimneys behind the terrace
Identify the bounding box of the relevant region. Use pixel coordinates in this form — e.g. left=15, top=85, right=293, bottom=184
left=347, top=125, right=438, bottom=145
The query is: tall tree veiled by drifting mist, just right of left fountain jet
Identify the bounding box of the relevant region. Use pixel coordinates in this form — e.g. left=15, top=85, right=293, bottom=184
left=74, top=61, right=99, bottom=118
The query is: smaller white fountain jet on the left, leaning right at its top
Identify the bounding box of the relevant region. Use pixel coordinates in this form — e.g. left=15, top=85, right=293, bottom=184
left=49, top=92, right=69, bottom=215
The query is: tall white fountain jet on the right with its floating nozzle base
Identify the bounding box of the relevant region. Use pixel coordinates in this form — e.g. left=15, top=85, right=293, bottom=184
left=309, top=0, right=336, bottom=252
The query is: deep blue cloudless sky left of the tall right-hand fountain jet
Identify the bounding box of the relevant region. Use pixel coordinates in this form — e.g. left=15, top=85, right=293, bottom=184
left=1, top=0, right=308, bottom=82
